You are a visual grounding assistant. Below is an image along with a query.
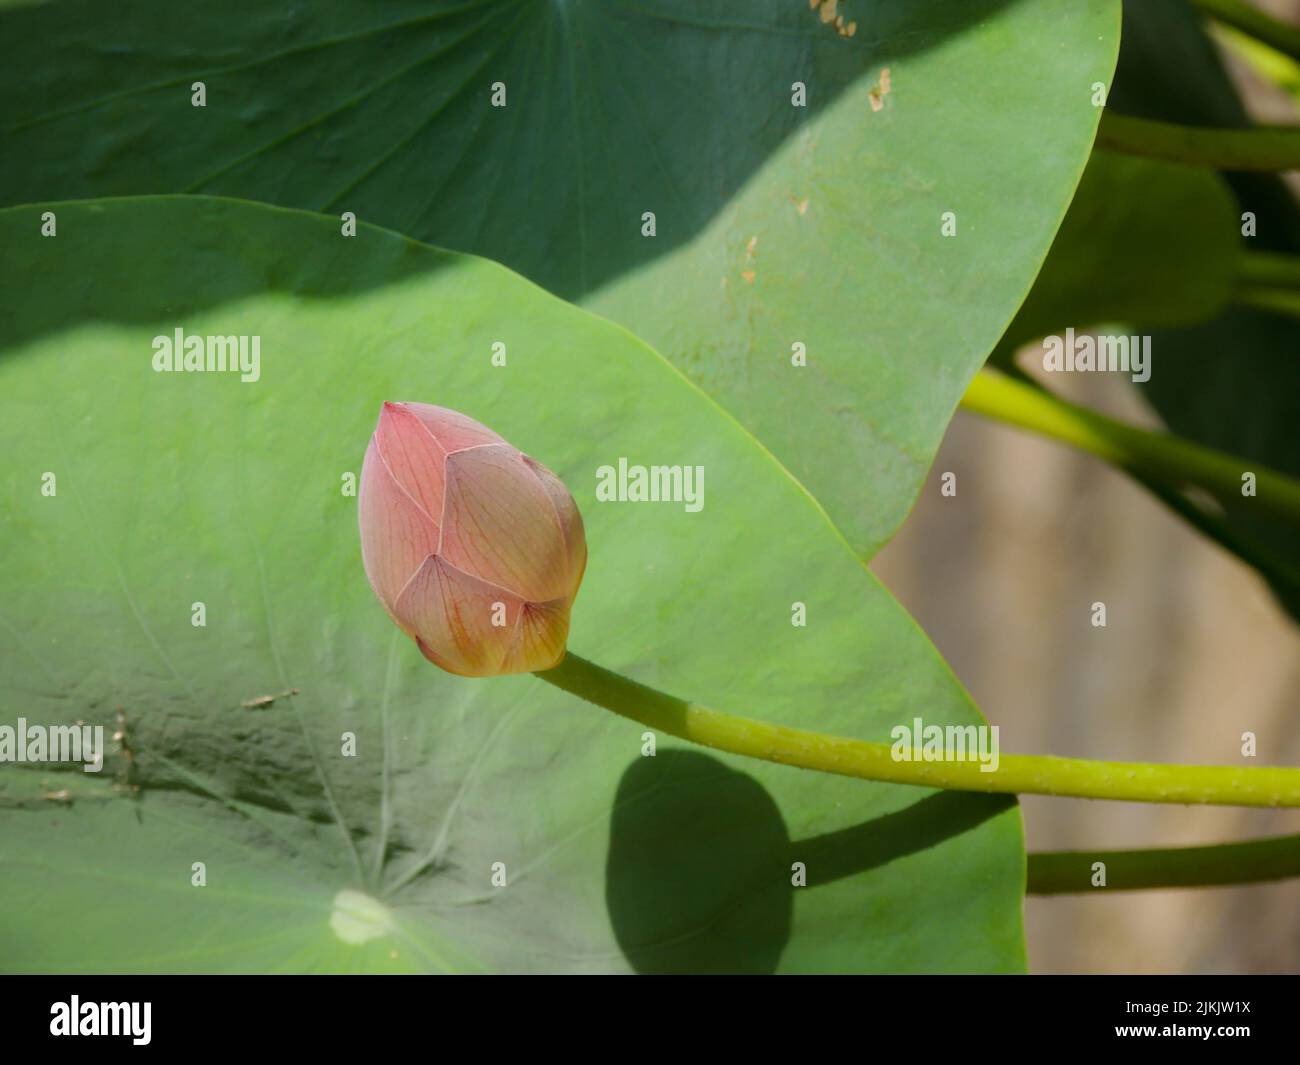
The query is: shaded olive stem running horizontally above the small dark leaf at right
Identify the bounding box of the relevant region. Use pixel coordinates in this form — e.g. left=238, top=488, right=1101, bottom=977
left=1096, top=111, right=1300, bottom=170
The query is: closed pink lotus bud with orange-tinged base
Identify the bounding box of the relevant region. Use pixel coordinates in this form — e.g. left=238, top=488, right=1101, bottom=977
left=358, top=403, right=586, bottom=676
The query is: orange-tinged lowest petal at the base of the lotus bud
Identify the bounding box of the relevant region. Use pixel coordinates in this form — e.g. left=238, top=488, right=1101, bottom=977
left=394, top=555, right=524, bottom=676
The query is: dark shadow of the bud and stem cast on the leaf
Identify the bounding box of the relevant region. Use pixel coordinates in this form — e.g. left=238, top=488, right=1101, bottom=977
left=605, top=750, right=1015, bottom=973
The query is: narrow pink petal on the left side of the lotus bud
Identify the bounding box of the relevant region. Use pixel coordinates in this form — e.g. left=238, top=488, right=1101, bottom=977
left=356, top=438, right=438, bottom=614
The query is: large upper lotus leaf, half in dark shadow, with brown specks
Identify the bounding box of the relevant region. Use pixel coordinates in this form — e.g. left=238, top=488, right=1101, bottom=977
left=0, top=0, right=1119, bottom=555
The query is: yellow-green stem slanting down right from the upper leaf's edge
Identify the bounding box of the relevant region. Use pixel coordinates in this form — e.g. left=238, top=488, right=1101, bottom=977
left=961, top=371, right=1300, bottom=525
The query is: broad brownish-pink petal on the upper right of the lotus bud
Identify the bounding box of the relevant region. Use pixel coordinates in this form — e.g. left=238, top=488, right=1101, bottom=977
left=441, top=445, right=569, bottom=602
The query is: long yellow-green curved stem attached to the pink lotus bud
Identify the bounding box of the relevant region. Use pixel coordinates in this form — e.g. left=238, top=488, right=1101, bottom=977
left=536, top=651, right=1300, bottom=806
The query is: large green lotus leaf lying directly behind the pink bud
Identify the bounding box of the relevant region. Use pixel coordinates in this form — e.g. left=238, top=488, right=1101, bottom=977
left=0, top=196, right=1024, bottom=971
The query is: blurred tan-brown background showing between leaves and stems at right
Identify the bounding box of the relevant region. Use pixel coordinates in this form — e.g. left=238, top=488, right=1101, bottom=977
left=872, top=0, right=1300, bottom=973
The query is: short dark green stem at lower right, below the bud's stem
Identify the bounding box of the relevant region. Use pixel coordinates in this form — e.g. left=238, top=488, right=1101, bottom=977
left=1026, top=835, right=1300, bottom=895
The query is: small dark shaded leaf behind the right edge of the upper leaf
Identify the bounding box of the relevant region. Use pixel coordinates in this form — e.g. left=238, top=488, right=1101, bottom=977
left=1000, top=151, right=1240, bottom=358
